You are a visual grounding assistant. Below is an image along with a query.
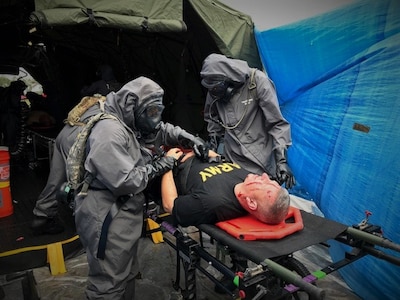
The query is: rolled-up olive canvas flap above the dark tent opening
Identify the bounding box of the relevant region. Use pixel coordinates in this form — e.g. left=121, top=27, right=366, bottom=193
left=31, top=0, right=186, bottom=32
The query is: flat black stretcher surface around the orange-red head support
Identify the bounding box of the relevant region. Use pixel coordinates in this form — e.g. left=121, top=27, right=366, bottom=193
left=198, top=211, right=348, bottom=263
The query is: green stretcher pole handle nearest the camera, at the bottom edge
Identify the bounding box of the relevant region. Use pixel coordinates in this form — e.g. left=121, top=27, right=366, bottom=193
left=263, top=258, right=325, bottom=299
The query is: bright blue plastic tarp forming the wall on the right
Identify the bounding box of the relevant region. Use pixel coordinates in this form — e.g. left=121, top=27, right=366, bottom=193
left=256, top=0, right=400, bottom=299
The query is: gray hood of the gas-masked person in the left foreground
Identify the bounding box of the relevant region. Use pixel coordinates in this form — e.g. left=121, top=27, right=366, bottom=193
left=105, top=76, right=164, bottom=131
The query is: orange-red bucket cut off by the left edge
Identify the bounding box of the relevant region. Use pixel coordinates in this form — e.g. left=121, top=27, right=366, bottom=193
left=0, top=147, right=14, bottom=218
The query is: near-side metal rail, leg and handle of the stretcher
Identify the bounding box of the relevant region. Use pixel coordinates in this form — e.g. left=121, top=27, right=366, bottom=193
left=152, top=218, right=325, bottom=300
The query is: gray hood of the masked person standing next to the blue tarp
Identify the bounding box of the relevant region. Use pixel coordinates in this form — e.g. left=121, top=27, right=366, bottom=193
left=200, top=53, right=250, bottom=87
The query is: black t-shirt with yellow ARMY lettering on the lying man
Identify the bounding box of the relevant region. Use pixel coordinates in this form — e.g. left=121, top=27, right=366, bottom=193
left=172, top=157, right=249, bottom=226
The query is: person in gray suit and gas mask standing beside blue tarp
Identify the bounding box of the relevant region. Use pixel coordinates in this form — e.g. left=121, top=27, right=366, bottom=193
left=200, top=53, right=295, bottom=189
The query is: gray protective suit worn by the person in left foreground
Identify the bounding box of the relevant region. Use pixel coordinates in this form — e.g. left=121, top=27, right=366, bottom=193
left=75, top=77, right=200, bottom=299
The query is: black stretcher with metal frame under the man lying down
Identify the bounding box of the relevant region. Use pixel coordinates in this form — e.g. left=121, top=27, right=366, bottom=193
left=148, top=206, right=400, bottom=300
